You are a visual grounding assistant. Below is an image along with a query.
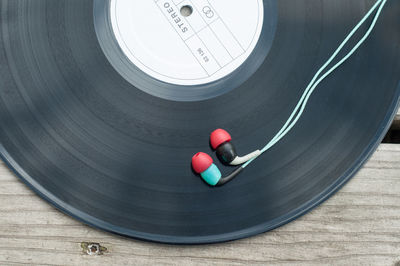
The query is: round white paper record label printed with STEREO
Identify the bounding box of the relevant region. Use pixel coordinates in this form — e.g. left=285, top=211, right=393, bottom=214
left=110, top=0, right=264, bottom=85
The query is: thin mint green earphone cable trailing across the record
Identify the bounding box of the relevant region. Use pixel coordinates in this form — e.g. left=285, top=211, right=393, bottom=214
left=242, top=0, right=387, bottom=168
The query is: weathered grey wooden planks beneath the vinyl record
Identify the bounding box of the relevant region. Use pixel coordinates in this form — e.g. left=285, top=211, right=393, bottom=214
left=0, top=108, right=400, bottom=265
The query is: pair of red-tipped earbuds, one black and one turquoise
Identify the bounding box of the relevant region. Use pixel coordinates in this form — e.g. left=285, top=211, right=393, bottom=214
left=192, top=129, right=261, bottom=187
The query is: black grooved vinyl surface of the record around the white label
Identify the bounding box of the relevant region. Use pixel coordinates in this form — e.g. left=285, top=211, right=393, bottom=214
left=0, top=0, right=400, bottom=244
